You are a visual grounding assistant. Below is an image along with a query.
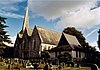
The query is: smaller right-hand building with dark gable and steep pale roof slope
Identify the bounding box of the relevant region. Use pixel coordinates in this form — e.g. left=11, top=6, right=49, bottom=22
left=49, top=33, right=85, bottom=62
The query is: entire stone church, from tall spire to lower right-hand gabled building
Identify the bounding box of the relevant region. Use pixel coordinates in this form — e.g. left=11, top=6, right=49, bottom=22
left=14, top=7, right=85, bottom=59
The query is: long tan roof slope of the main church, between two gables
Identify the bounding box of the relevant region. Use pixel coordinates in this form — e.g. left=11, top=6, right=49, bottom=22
left=36, top=26, right=61, bottom=45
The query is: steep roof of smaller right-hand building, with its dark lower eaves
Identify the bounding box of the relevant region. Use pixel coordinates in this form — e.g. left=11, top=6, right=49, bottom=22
left=49, top=33, right=84, bottom=52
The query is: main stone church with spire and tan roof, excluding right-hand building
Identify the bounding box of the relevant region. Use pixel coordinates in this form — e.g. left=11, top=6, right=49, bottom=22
left=14, top=7, right=61, bottom=59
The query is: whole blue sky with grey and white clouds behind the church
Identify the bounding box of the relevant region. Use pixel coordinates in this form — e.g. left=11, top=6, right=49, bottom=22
left=0, top=0, right=100, bottom=50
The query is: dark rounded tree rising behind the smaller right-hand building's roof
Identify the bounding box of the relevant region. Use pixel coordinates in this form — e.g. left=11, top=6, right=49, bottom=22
left=63, top=27, right=86, bottom=47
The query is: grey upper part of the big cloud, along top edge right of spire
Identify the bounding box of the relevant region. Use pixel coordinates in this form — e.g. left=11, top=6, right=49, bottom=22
left=29, top=0, right=95, bottom=19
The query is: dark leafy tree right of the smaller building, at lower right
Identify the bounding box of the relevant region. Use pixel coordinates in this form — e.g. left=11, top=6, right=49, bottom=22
left=83, top=43, right=100, bottom=64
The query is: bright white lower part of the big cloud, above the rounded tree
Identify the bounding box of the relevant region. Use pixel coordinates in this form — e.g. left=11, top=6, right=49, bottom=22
left=55, top=7, right=100, bottom=29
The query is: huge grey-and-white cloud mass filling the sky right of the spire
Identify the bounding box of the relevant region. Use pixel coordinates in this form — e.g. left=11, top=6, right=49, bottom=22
left=29, top=0, right=100, bottom=29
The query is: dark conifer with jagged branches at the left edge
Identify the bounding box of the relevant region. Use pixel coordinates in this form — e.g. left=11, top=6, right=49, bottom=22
left=0, top=16, right=11, bottom=47
